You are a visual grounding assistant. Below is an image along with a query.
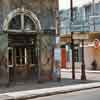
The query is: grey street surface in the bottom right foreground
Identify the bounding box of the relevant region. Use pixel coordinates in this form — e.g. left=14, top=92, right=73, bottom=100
left=29, top=88, right=100, bottom=100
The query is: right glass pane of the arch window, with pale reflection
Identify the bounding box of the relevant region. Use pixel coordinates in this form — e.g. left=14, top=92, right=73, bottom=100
left=24, top=16, right=36, bottom=31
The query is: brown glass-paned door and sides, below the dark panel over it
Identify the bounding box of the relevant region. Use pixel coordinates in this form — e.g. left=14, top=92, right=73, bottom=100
left=8, top=47, right=38, bottom=81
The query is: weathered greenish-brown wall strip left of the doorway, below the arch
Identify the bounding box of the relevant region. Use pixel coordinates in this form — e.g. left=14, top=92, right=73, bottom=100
left=0, top=34, right=9, bottom=84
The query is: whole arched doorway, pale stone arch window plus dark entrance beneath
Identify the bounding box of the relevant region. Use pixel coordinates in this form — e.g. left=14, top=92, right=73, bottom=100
left=3, top=8, right=41, bottom=81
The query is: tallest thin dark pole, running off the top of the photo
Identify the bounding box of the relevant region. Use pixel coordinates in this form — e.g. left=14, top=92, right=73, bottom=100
left=70, top=0, right=75, bottom=80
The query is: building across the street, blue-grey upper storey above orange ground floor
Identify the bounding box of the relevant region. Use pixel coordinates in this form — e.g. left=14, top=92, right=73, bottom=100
left=59, top=2, right=100, bottom=69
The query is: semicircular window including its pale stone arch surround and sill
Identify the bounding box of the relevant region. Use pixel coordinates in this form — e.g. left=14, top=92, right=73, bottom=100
left=3, top=8, right=41, bottom=31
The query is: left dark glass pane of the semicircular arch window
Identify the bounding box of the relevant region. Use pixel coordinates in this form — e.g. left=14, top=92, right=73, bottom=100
left=8, top=15, right=21, bottom=29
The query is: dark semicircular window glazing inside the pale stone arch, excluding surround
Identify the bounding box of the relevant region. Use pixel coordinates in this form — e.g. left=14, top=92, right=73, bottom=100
left=8, top=14, right=36, bottom=31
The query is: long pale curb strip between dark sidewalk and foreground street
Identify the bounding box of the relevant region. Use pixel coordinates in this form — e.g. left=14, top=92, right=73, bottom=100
left=0, top=82, right=100, bottom=100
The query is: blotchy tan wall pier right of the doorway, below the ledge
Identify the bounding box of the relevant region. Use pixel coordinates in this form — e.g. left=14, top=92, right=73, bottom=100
left=40, top=34, right=55, bottom=79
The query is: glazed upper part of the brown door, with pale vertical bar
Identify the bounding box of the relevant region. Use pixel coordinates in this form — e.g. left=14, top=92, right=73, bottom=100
left=15, top=48, right=36, bottom=65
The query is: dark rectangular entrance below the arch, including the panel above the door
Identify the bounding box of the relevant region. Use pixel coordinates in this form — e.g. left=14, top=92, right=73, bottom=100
left=8, top=34, right=38, bottom=81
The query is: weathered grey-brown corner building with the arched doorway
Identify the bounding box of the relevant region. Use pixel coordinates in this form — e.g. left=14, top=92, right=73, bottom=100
left=0, top=0, right=57, bottom=83
